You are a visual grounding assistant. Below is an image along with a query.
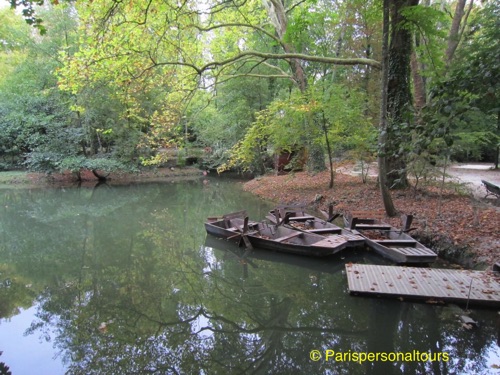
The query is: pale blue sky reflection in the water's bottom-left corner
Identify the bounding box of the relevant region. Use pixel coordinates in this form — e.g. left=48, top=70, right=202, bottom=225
left=0, top=306, right=65, bottom=375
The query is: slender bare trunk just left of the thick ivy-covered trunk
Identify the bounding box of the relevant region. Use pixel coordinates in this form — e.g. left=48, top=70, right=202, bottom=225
left=378, top=0, right=396, bottom=216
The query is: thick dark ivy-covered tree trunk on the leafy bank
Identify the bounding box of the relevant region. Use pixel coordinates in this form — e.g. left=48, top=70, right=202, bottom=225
left=385, top=0, right=418, bottom=188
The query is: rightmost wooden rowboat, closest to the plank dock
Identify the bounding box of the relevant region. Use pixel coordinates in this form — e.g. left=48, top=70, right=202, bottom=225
left=344, top=213, right=437, bottom=264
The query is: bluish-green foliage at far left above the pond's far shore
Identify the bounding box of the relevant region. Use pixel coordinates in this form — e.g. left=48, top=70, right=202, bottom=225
left=0, top=7, right=148, bottom=172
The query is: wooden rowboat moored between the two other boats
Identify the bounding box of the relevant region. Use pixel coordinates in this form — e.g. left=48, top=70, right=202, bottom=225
left=266, top=206, right=365, bottom=247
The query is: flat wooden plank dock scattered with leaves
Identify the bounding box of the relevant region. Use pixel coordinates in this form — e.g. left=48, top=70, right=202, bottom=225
left=345, top=263, right=500, bottom=308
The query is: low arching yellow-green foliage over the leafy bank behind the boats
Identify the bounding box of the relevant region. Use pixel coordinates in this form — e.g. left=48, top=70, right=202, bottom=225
left=219, top=82, right=377, bottom=172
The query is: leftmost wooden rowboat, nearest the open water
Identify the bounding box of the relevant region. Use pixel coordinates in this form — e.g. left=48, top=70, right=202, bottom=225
left=205, top=212, right=360, bottom=257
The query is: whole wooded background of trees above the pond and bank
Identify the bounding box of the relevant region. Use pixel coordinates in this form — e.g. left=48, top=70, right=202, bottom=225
left=0, top=0, right=500, bottom=214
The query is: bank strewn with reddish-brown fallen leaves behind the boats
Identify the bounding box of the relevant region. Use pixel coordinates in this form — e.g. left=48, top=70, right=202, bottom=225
left=244, top=166, right=500, bottom=269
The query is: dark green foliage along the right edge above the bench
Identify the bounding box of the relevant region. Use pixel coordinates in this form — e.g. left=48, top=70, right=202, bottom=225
left=418, top=2, right=500, bottom=164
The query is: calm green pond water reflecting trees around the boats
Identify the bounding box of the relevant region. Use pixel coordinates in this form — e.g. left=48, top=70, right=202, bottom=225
left=0, top=179, right=500, bottom=375
